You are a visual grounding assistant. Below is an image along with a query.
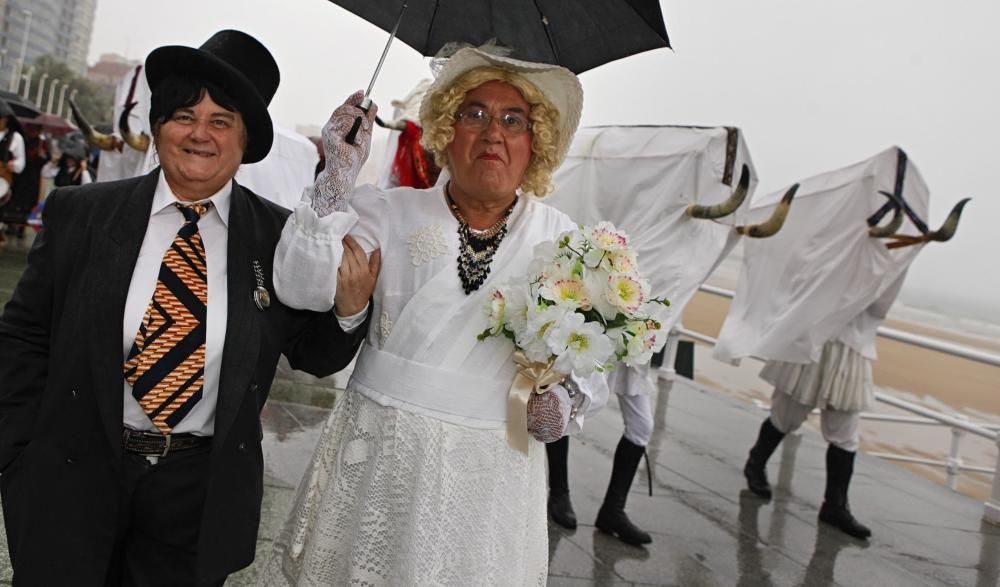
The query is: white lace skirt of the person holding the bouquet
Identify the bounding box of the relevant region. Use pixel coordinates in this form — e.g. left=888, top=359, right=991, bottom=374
left=260, top=393, right=548, bottom=586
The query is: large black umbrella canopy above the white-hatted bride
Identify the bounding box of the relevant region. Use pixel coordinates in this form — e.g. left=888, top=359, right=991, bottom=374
left=330, top=0, right=670, bottom=74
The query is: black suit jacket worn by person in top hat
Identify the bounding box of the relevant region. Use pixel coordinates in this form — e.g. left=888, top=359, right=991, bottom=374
left=0, top=169, right=367, bottom=585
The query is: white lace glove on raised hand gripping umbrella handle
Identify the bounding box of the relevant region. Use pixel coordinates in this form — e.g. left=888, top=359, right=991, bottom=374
left=312, top=91, right=378, bottom=218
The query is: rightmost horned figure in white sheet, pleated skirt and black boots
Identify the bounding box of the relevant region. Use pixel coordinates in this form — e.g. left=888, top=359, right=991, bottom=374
left=715, top=147, right=967, bottom=539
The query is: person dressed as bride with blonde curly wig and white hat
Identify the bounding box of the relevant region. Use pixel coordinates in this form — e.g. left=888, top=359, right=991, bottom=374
left=254, top=48, right=607, bottom=585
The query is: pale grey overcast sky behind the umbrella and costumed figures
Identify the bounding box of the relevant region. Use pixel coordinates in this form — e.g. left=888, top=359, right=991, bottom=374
left=90, top=0, right=1000, bottom=324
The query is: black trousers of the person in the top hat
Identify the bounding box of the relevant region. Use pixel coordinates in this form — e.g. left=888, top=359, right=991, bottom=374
left=106, top=445, right=226, bottom=587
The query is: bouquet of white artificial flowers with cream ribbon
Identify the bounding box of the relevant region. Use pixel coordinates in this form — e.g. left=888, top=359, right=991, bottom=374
left=479, top=222, right=670, bottom=450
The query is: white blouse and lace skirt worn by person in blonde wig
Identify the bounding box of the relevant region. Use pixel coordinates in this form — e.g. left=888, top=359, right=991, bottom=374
left=262, top=180, right=607, bottom=585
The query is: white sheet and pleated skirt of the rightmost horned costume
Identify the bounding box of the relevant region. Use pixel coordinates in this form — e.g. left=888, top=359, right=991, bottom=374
left=715, top=147, right=929, bottom=422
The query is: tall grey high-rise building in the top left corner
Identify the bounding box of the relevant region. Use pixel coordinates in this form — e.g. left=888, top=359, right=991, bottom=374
left=0, top=0, right=97, bottom=91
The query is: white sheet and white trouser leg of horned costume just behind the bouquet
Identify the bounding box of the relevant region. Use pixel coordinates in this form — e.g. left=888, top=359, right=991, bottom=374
left=546, top=126, right=757, bottom=446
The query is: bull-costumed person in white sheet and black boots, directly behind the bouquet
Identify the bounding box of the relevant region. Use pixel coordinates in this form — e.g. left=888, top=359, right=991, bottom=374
left=546, top=126, right=785, bottom=545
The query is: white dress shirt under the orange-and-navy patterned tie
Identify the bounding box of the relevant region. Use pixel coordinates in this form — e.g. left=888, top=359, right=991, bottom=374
left=122, top=171, right=368, bottom=436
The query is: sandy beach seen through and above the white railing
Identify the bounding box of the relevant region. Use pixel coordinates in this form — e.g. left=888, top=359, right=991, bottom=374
left=683, top=280, right=1000, bottom=500
